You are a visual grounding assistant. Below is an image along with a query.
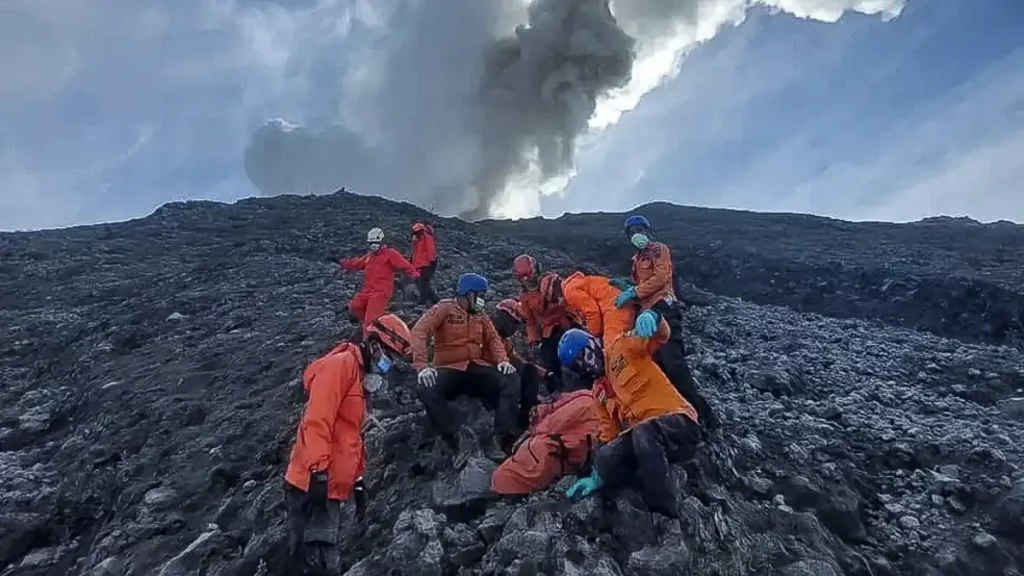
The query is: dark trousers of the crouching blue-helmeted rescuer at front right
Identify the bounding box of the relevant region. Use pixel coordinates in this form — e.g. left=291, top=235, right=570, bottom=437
left=594, top=414, right=700, bottom=518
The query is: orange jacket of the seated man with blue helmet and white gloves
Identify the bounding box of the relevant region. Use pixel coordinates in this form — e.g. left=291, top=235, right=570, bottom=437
left=413, top=298, right=508, bottom=370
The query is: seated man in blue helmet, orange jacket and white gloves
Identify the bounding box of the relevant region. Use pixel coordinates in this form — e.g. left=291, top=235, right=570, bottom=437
left=413, top=274, right=520, bottom=468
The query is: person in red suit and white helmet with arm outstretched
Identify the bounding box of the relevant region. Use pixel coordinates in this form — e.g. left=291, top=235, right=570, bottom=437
left=339, top=228, right=420, bottom=331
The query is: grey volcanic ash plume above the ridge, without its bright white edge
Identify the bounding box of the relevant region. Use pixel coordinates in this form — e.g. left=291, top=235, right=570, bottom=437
left=246, top=0, right=634, bottom=218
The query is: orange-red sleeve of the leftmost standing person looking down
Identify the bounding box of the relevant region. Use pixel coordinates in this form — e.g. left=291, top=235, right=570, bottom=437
left=302, top=355, right=353, bottom=471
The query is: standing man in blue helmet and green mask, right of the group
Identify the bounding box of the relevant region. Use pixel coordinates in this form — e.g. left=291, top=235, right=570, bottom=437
left=615, top=215, right=718, bottom=428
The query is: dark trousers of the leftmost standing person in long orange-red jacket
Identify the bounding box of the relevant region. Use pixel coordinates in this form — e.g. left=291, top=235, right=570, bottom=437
left=285, top=482, right=341, bottom=576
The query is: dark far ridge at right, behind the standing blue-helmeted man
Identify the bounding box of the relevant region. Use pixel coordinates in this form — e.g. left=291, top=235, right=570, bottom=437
left=487, top=203, right=1024, bottom=349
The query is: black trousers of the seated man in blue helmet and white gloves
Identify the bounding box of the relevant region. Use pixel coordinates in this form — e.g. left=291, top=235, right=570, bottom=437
left=416, top=363, right=520, bottom=442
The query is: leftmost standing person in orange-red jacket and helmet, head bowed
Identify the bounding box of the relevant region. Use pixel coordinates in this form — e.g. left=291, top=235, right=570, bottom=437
left=285, top=314, right=412, bottom=576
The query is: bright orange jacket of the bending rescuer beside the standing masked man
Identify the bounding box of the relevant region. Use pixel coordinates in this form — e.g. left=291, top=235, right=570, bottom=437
left=562, top=272, right=636, bottom=342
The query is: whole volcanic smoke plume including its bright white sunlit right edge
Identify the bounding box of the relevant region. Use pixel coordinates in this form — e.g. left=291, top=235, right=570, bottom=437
left=239, top=0, right=905, bottom=218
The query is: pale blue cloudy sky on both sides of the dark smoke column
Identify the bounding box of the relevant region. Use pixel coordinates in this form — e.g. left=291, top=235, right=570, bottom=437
left=0, top=0, right=1024, bottom=230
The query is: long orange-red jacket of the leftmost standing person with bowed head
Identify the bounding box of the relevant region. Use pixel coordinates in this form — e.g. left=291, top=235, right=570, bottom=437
left=285, top=342, right=367, bottom=500
